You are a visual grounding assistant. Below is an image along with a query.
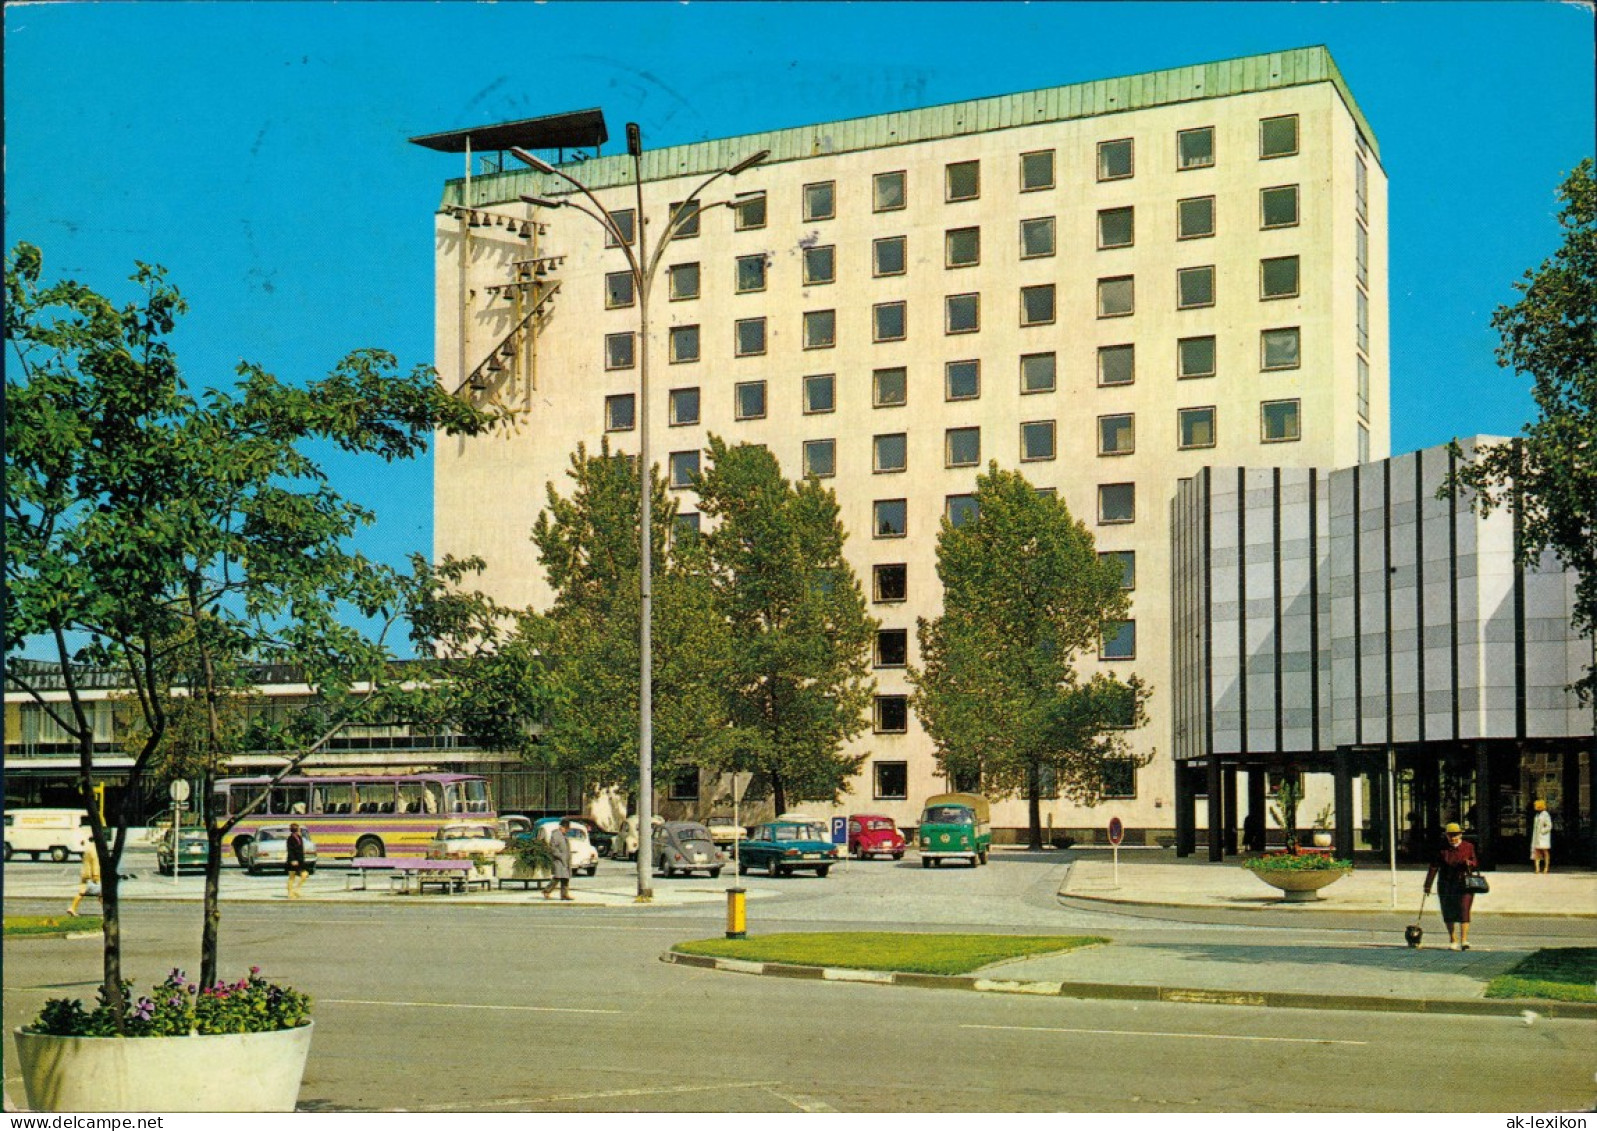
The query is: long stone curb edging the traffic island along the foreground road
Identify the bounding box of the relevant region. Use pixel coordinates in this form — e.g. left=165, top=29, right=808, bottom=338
left=660, top=950, right=1597, bottom=1021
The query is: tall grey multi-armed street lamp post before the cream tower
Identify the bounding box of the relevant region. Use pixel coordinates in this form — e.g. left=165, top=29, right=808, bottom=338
left=511, top=121, right=770, bottom=903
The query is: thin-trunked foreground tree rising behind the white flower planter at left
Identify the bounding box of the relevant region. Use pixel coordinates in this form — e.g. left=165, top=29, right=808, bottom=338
left=5, top=244, right=495, bottom=1013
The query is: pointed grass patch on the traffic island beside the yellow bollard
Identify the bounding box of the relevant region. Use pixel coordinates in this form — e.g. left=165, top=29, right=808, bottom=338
left=672, top=931, right=1108, bottom=974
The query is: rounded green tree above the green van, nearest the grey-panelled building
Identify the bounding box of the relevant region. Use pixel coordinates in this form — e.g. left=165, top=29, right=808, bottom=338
left=909, top=463, right=1150, bottom=848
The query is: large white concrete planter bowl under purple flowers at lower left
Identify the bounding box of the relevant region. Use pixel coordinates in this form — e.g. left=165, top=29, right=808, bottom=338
left=14, top=1022, right=315, bottom=1112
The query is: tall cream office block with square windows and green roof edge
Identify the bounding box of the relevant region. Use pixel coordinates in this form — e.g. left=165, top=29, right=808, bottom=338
left=414, top=48, right=1388, bottom=837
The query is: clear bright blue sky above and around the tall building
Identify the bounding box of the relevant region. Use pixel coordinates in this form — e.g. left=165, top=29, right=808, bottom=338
left=5, top=0, right=1594, bottom=597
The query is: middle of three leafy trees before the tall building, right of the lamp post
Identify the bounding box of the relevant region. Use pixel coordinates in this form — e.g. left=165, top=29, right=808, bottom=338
left=693, top=436, right=877, bottom=813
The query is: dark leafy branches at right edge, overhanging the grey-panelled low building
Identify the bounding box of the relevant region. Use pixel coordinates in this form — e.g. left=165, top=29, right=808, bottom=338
left=1444, top=158, right=1597, bottom=700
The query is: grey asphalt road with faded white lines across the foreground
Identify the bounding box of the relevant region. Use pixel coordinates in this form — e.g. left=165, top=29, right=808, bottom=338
left=3, top=863, right=1594, bottom=1112
